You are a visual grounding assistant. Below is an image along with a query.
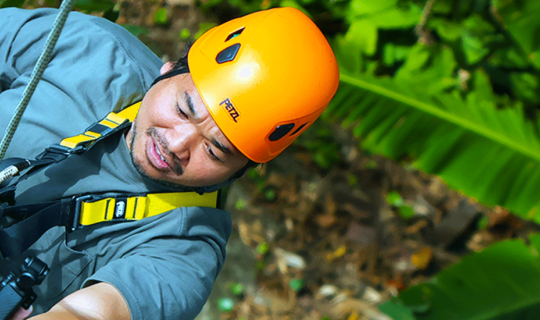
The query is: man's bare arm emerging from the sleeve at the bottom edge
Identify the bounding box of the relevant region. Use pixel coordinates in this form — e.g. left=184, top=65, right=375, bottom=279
left=30, top=282, right=131, bottom=320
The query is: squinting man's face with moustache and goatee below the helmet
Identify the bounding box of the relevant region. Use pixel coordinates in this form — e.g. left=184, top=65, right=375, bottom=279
left=126, top=63, right=248, bottom=187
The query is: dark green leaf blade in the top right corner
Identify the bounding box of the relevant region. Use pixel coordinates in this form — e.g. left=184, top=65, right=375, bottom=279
left=492, top=0, right=540, bottom=69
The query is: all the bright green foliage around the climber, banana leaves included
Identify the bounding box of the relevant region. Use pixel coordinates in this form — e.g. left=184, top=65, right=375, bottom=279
left=6, top=0, right=540, bottom=320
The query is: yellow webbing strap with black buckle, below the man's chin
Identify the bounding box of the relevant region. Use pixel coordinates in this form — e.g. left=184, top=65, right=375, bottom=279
left=79, top=191, right=218, bottom=226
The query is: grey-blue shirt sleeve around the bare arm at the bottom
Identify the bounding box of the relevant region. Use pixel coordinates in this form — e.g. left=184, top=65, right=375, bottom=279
left=83, top=208, right=231, bottom=320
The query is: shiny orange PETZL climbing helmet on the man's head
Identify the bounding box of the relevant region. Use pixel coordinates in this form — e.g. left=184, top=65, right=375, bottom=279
left=188, top=8, right=339, bottom=163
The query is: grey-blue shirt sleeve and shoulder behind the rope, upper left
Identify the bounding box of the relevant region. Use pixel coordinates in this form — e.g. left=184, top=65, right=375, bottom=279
left=0, top=8, right=162, bottom=157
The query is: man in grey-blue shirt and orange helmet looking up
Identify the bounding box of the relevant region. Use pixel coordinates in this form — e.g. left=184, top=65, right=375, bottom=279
left=0, top=8, right=339, bottom=319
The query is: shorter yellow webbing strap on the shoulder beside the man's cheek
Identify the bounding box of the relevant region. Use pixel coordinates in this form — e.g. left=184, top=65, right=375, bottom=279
left=60, top=102, right=141, bottom=149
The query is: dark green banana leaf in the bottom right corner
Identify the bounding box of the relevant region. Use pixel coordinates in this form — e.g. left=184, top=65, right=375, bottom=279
left=380, top=235, right=540, bottom=320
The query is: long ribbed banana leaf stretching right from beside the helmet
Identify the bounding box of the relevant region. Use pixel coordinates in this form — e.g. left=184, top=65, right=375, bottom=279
left=328, top=53, right=540, bottom=222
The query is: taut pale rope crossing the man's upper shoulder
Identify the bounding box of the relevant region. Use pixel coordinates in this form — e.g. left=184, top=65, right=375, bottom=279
left=0, top=0, right=73, bottom=161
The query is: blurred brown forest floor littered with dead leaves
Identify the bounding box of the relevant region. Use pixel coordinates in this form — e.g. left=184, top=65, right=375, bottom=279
left=99, top=0, right=537, bottom=320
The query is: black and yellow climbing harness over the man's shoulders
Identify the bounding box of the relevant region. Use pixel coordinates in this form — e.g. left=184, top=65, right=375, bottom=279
left=0, top=102, right=221, bottom=256
